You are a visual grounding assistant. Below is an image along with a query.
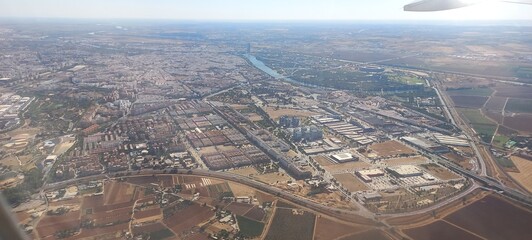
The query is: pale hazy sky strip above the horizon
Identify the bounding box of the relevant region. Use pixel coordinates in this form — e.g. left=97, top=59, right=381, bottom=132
left=0, top=0, right=532, bottom=21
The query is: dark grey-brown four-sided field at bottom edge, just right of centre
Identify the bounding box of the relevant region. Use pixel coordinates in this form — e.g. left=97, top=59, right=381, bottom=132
left=264, top=203, right=316, bottom=240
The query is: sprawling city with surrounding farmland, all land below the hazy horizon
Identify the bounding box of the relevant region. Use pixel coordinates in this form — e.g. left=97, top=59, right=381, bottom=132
left=0, top=8, right=532, bottom=239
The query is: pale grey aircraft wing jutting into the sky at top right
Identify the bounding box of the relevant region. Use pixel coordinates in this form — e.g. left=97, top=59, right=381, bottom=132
left=404, top=0, right=532, bottom=12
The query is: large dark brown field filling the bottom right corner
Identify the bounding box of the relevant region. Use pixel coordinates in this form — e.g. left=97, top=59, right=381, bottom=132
left=444, top=195, right=532, bottom=240
